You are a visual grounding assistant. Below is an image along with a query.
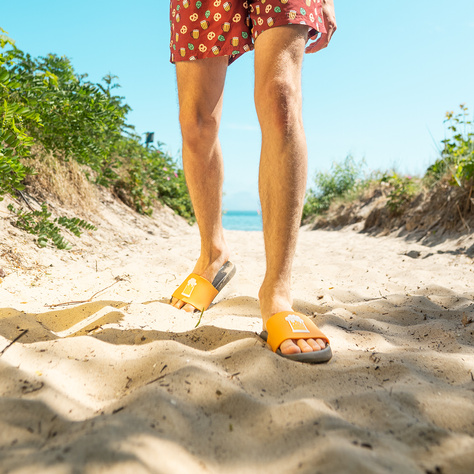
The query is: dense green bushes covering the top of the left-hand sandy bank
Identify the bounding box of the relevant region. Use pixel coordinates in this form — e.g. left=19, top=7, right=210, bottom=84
left=0, top=29, right=193, bottom=248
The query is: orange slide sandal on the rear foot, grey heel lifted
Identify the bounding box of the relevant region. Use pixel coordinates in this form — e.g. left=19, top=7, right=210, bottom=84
left=173, top=261, right=236, bottom=311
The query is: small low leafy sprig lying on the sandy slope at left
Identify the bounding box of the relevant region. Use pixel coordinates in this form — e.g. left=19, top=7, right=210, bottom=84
left=8, top=203, right=97, bottom=250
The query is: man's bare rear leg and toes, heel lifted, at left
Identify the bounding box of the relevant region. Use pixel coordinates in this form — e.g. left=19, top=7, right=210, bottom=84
left=171, top=57, right=229, bottom=311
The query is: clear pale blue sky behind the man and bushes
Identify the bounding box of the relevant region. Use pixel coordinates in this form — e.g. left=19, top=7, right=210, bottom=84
left=0, top=0, right=474, bottom=208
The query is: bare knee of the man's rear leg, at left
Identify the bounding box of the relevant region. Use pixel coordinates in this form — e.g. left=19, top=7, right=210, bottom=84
left=179, top=108, right=219, bottom=148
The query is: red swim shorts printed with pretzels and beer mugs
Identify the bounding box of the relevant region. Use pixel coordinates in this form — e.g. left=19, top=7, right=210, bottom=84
left=170, top=0, right=326, bottom=63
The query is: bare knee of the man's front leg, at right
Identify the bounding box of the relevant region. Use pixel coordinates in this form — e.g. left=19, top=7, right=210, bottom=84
left=255, top=77, right=302, bottom=135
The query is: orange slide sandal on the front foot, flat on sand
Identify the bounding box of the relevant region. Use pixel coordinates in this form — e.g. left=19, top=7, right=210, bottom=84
left=260, top=311, right=332, bottom=364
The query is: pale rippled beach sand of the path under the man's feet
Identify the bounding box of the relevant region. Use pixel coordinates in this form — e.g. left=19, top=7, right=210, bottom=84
left=0, top=194, right=474, bottom=474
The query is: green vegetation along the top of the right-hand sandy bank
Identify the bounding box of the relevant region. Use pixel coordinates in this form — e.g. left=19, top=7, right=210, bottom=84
left=303, top=104, right=474, bottom=220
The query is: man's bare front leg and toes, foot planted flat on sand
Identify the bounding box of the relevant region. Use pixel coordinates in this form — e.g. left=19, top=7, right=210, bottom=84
left=255, top=25, right=325, bottom=354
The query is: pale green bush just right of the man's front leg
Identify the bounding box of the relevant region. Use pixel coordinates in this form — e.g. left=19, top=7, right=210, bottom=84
left=303, top=155, right=365, bottom=219
